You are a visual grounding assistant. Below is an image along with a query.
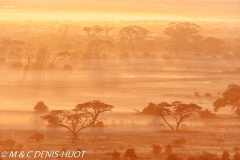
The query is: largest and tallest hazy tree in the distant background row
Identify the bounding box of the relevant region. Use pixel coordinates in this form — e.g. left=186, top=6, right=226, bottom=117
left=164, top=22, right=201, bottom=51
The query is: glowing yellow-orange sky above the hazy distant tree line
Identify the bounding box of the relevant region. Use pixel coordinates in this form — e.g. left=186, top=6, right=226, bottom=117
left=0, top=0, right=240, bottom=21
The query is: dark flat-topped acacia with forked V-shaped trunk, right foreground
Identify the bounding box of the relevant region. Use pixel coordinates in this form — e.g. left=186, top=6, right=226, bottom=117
left=140, top=101, right=202, bottom=131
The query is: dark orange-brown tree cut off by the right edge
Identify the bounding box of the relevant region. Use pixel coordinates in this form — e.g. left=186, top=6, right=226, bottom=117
left=213, top=84, right=240, bottom=115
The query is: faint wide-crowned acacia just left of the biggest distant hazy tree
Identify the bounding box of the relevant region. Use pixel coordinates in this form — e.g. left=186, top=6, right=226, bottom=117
left=119, top=26, right=151, bottom=43
